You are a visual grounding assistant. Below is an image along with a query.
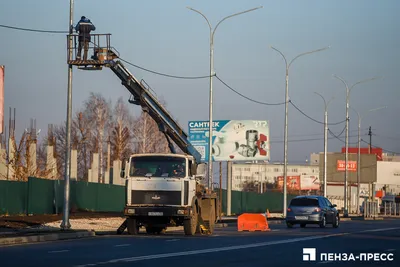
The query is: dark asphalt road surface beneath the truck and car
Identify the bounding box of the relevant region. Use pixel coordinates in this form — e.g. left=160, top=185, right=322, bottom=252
left=0, top=220, right=400, bottom=267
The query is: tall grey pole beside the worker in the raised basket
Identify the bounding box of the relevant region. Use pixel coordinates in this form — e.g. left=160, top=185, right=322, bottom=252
left=60, top=0, right=74, bottom=230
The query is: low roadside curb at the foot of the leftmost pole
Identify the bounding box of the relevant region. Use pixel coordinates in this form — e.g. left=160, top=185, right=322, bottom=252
left=0, top=231, right=96, bottom=246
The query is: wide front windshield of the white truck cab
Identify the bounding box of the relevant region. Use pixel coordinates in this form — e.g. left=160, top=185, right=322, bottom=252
left=129, top=156, right=186, bottom=178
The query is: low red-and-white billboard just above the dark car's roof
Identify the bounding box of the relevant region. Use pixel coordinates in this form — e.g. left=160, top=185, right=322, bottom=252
left=278, top=175, right=320, bottom=190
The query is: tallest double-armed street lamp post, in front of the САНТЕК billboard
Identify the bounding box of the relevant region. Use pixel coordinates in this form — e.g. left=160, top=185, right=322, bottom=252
left=187, top=6, right=262, bottom=190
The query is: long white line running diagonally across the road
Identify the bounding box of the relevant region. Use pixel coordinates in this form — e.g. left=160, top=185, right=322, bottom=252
left=75, top=227, right=400, bottom=267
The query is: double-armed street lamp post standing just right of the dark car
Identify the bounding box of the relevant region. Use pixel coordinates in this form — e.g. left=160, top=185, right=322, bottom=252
left=333, top=75, right=377, bottom=217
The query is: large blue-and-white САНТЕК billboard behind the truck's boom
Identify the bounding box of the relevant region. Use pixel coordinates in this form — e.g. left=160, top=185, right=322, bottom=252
left=188, top=120, right=270, bottom=162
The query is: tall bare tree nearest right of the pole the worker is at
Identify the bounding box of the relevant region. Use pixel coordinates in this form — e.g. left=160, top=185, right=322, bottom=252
left=84, top=92, right=111, bottom=183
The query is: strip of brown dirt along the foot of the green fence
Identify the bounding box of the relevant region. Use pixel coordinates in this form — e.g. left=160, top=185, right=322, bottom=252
left=0, top=212, right=123, bottom=231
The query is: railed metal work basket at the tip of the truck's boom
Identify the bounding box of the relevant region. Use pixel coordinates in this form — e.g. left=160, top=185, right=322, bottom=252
left=67, top=34, right=119, bottom=70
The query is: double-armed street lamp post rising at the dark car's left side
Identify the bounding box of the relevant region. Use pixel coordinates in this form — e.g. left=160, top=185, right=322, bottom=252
left=271, top=46, right=329, bottom=217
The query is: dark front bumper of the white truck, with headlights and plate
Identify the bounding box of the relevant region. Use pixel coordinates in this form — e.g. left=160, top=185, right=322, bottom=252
left=124, top=206, right=192, bottom=219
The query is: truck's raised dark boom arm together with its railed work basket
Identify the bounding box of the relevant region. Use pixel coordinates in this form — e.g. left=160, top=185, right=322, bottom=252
left=67, top=34, right=201, bottom=163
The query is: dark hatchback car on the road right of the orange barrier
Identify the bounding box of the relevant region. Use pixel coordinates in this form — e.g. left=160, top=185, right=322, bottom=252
left=286, top=196, right=340, bottom=228
